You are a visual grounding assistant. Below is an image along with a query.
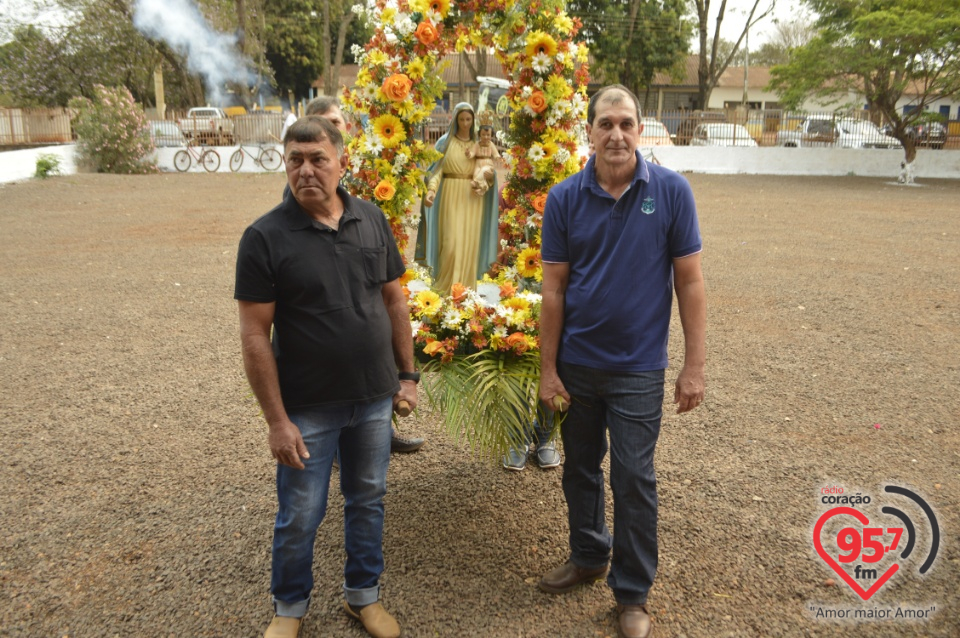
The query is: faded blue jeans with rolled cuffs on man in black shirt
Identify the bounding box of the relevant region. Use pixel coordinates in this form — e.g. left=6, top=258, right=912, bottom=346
left=270, top=398, right=393, bottom=618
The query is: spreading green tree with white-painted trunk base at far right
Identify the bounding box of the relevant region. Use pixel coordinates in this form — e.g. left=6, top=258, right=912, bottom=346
left=770, top=0, right=960, bottom=175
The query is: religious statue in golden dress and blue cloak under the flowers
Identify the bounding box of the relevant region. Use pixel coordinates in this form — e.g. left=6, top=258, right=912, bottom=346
left=416, top=102, right=499, bottom=294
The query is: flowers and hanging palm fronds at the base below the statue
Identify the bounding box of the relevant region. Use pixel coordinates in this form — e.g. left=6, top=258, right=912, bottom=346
left=401, top=262, right=556, bottom=458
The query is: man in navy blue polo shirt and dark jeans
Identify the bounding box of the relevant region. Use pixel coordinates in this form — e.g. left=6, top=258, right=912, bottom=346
left=540, top=85, right=706, bottom=638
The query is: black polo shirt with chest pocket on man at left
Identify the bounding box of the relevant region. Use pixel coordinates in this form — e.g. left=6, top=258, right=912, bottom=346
left=234, top=187, right=405, bottom=410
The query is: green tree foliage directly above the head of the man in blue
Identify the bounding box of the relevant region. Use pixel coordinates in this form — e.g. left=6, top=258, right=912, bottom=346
left=567, top=0, right=693, bottom=108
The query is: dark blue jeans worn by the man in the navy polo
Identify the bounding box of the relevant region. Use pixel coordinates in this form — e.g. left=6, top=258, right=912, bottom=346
left=557, top=363, right=664, bottom=605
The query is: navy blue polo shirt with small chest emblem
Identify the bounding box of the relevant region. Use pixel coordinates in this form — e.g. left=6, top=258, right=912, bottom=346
left=541, top=153, right=702, bottom=372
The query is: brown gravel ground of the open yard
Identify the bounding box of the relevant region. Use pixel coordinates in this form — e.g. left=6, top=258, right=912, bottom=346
left=0, top=174, right=960, bottom=638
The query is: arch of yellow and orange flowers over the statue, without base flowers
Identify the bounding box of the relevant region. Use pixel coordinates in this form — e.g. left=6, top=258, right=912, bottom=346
left=342, top=0, right=588, bottom=264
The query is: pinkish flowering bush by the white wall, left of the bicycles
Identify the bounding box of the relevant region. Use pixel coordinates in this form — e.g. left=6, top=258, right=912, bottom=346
left=70, top=84, right=158, bottom=174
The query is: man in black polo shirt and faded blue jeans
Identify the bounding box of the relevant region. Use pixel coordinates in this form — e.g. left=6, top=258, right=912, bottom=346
left=234, top=116, right=419, bottom=638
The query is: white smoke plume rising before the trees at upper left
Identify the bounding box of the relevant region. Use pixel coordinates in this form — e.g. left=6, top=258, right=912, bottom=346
left=133, top=0, right=255, bottom=105
